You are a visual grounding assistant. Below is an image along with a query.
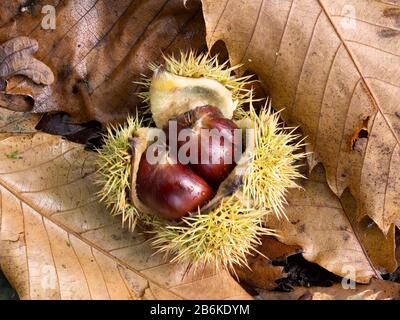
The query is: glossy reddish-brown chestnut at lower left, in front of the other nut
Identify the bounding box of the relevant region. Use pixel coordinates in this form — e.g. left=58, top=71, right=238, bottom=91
left=136, top=148, right=215, bottom=220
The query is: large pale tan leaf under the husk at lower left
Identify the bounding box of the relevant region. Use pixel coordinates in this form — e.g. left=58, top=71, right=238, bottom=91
left=0, top=110, right=250, bottom=299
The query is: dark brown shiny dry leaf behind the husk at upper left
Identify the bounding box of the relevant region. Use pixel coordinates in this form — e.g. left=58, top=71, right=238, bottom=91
left=0, top=0, right=206, bottom=123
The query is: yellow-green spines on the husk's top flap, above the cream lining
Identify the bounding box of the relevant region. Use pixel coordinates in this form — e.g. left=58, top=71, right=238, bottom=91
left=136, top=51, right=254, bottom=108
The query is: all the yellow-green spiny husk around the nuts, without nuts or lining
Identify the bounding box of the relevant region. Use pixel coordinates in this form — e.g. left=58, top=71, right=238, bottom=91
left=98, top=52, right=304, bottom=270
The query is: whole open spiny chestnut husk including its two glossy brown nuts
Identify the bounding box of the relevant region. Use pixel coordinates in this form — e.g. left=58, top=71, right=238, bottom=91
left=98, top=53, right=304, bottom=268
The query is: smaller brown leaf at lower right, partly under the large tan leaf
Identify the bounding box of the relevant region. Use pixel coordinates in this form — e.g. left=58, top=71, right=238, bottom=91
left=268, top=166, right=397, bottom=283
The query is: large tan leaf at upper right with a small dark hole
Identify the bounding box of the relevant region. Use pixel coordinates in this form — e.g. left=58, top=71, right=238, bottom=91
left=202, top=0, right=400, bottom=233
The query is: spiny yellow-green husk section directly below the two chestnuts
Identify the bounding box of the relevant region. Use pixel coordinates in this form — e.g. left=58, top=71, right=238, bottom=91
left=153, top=195, right=275, bottom=270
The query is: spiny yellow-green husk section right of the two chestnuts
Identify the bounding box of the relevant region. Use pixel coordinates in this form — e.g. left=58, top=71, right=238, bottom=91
left=236, top=101, right=305, bottom=218
